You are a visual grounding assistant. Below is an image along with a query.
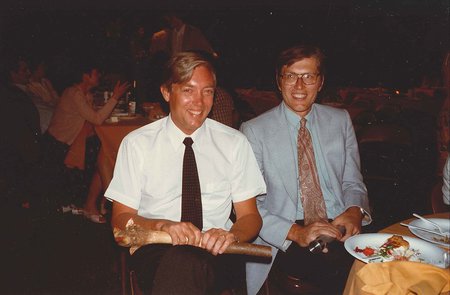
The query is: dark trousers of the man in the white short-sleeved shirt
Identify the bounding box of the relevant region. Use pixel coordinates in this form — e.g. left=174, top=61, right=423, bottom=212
left=130, top=244, right=245, bottom=295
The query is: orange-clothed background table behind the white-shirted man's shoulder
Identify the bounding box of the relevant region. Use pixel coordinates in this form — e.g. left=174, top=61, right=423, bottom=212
left=95, top=115, right=152, bottom=188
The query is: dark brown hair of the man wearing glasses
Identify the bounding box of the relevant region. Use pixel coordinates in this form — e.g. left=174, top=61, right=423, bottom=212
left=275, top=45, right=325, bottom=83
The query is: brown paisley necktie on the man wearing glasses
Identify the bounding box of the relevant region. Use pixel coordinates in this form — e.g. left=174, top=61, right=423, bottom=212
left=297, top=118, right=327, bottom=225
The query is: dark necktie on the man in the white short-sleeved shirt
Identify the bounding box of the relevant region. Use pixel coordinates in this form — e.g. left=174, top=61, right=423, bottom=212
left=181, top=137, right=203, bottom=230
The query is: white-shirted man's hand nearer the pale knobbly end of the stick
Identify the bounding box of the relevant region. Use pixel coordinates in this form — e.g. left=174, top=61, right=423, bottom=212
left=161, top=220, right=202, bottom=247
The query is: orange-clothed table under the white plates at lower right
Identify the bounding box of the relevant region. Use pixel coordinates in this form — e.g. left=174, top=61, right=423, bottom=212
left=343, top=212, right=450, bottom=295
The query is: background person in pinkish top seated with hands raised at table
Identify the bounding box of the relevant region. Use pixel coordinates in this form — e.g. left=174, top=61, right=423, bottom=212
left=45, top=60, right=129, bottom=223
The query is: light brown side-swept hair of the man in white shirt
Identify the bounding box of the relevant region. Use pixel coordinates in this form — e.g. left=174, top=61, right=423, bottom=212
left=161, top=51, right=216, bottom=91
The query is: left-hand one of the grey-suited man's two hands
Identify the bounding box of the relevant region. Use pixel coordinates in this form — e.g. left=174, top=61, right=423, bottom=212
left=287, top=221, right=342, bottom=252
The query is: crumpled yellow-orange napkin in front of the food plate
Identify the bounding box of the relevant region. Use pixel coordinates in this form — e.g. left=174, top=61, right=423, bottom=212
left=346, top=261, right=450, bottom=295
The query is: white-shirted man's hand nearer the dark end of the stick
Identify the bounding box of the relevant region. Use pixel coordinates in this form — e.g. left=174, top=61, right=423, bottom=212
left=200, top=228, right=238, bottom=255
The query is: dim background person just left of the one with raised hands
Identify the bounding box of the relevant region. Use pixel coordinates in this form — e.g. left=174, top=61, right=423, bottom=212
left=27, top=60, right=59, bottom=133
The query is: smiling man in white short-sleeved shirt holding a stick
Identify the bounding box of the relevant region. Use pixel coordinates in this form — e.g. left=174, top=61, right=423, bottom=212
left=105, top=52, right=265, bottom=295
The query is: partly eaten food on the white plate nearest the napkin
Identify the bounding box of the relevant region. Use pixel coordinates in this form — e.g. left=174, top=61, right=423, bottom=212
left=355, top=235, right=422, bottom=261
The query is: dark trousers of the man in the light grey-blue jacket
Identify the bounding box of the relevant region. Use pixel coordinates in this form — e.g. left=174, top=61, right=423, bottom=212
left=273, top=220, right=354, bottom=294
